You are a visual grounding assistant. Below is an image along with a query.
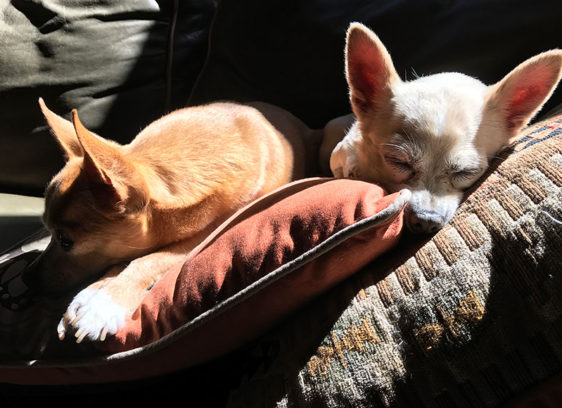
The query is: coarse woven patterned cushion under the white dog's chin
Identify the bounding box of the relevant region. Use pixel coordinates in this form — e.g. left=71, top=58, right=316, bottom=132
left=225, top=116, right=562, bottom=407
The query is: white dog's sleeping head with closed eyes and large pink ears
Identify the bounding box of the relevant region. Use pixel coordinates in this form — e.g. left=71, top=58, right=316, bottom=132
left=330, top=23, right=562, bottom=233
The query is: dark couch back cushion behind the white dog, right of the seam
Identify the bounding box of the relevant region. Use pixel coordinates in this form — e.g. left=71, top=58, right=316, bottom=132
left=189, top=0, right=562, bottom=127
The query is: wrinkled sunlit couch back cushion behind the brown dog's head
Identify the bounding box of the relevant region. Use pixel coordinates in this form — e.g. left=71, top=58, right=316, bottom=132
left=0, top=0, right=214, bottom=194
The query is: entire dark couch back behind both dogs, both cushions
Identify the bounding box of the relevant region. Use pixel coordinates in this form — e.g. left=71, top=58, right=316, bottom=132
left=0, top=0, right=562, bottom=195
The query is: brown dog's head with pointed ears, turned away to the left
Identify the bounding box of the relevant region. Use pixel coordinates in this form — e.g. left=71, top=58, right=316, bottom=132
left=24, top=99, right=148, bottom=293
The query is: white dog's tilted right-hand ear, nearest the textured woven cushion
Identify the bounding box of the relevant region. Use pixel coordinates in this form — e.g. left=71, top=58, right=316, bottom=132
left=486, top=50, right=562, bottom=137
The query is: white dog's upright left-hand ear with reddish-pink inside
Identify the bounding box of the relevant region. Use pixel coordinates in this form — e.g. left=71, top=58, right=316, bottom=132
left=345, top=23, right=400, bottom=119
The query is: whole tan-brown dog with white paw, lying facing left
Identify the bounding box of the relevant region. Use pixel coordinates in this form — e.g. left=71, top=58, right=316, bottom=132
left=24, top=99, right=321, bottom=342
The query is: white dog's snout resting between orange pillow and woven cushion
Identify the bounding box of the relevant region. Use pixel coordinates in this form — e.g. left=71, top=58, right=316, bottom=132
left=404, top=191, right=461, bottom=234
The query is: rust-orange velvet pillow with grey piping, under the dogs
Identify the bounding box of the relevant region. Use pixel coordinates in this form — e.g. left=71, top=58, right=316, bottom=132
left=0, top=179, right=402, bottom=384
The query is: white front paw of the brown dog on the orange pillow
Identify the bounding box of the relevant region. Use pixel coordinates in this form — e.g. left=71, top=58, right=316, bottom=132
left=57, top=289, right=127, bottom=343
